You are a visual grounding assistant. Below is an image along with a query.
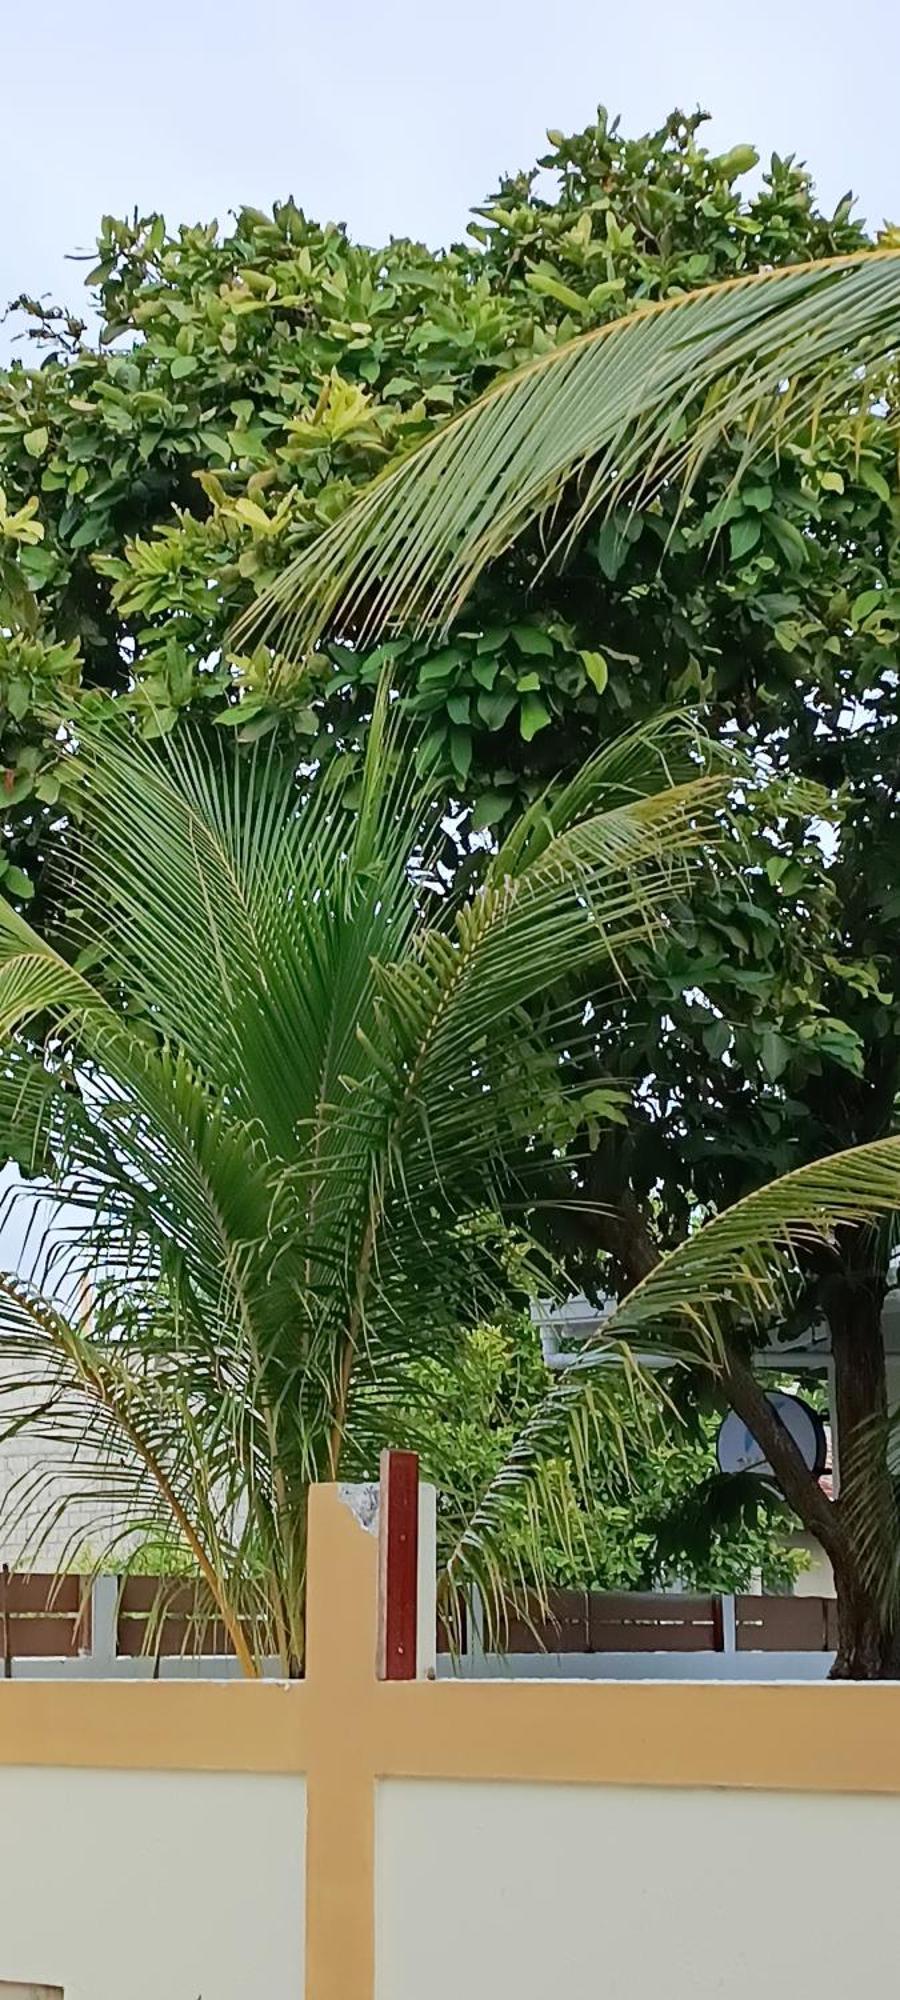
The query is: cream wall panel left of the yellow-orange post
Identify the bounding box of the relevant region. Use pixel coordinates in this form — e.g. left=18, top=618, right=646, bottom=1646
left=0, top=1768, right=306, bottom=2000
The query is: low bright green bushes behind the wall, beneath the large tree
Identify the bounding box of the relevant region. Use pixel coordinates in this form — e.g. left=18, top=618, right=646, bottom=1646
left=398, top=1316, right=798, bottom=1590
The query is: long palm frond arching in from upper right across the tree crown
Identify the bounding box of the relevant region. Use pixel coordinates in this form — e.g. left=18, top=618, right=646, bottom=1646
left=242, top=250, right=900, bottom=656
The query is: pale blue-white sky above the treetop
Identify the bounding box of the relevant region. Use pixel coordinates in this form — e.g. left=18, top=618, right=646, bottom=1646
left=0, top=0, right=900, bottom=354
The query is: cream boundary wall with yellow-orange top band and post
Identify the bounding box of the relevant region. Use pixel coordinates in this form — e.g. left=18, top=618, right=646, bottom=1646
left=0, top=1488, right=900, bottom=2000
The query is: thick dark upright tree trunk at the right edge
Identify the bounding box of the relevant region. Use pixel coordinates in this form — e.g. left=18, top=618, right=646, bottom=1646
left=824, top=1272, right=900, bottom=1680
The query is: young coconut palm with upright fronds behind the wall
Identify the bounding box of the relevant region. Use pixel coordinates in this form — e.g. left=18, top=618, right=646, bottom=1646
left=0, top=694, right=724, bottom=1672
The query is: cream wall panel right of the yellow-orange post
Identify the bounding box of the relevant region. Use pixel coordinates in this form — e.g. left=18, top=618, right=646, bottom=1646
left=376, top=1784, right=900, bottom=2000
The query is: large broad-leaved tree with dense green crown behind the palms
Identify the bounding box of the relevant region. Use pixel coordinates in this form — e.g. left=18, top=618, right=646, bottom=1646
left=0, top=114, right=900, bottom=1672
